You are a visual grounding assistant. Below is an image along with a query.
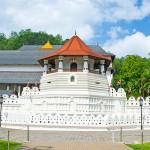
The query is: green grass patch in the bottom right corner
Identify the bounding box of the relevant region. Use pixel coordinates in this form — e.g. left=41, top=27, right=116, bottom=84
left=127, top=142, right=150, bottom=150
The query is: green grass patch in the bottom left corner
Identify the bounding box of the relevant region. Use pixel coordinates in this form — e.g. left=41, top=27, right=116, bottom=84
left=0, top=140, right=22, bottom=150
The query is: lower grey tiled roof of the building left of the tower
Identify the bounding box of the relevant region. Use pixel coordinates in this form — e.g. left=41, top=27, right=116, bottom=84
left=0, top=72, right=42, bottom=84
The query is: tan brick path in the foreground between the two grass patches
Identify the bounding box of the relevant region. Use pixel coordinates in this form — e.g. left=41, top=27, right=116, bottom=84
left=18, top=142, right=131, bottom=150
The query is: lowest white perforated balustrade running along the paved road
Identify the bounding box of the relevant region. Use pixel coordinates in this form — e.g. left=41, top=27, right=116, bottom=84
left=2, top=111, right=150, bottom=127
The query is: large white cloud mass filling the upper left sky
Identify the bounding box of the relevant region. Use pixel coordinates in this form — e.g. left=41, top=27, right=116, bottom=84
left=0, top=0, right=101, bottom=40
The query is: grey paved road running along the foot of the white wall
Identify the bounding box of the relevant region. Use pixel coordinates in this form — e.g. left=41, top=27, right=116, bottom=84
left=0, top=128, right=150, bottom=144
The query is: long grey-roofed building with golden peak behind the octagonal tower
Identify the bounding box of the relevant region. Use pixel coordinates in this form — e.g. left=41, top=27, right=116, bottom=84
left=0, top=37, right=115, bottom=95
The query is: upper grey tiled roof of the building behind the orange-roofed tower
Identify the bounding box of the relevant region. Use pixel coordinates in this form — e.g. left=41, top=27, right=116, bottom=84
left=0, top=42, right=112, bottom=65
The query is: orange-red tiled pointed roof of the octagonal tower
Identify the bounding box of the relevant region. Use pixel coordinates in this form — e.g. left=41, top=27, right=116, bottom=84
left=38, top=35, right=110, bottom=60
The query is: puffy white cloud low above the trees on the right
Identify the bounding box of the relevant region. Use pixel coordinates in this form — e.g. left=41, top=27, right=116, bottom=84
left=103, top=32, right=150, bottom=57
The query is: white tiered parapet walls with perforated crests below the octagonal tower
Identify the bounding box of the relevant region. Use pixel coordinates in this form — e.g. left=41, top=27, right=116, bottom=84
left=2, top=87, right=150, bottom=128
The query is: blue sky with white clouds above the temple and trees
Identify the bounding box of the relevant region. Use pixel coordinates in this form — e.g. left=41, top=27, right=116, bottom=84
left=0, top=0, right=150, bottom=57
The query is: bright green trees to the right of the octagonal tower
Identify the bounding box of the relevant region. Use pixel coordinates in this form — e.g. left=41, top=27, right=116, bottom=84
left=113, top=55, right=150, bottom=97
